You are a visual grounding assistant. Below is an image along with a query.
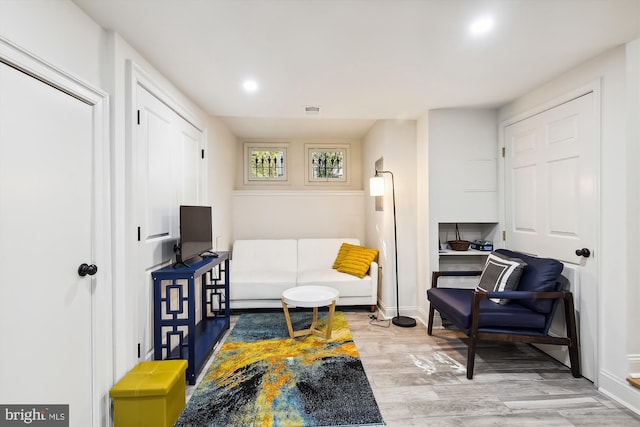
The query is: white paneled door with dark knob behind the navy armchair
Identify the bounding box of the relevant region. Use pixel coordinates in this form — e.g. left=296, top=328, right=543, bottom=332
left=504, top=93, right=599, bottom=381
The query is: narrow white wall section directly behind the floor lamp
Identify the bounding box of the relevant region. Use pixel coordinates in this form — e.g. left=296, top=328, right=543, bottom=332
left=362, top=120, right=418, bottom=316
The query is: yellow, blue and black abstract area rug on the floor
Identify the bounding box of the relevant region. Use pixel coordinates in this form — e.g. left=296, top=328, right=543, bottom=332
left=176, top=310, right=384, bottom=427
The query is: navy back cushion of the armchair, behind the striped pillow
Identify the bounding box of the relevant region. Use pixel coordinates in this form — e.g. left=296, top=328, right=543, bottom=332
left=495, top=249, right=564, bottom=314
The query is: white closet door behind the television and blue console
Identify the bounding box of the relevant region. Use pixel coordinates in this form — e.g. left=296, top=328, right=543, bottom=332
left=132, top=85, right=204, bottom=357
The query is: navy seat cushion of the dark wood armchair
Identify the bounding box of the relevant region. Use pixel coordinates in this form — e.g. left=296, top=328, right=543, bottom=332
left=427, top=288, right=546, bottom=335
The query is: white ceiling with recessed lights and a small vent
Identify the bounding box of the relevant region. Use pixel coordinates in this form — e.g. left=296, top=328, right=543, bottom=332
left=74, top=0, right=640, bottom=138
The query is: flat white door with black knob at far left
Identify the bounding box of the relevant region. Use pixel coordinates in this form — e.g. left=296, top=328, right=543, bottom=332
left=0, top=63, right=98, bottom=426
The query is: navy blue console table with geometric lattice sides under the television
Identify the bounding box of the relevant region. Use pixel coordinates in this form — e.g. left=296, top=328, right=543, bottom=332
left=151, top=252, right=231, bottom=385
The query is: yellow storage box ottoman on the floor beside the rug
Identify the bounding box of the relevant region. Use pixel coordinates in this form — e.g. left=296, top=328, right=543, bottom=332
left=109, top=359, right=187, bottom=427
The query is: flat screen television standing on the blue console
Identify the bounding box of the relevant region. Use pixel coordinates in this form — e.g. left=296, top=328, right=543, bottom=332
left=176, top=205, right=213, bottom=264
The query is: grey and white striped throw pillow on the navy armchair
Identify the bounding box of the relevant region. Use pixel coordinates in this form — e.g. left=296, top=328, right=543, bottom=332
left=476, top=252, right=527, bottom=304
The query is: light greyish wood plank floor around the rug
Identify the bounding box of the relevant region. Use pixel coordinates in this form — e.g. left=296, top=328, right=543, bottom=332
left=187, top=310, right=640, bottom=427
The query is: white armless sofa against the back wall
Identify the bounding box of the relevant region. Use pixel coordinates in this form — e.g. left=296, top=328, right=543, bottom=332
left=229, top=238, right=378, bottom=309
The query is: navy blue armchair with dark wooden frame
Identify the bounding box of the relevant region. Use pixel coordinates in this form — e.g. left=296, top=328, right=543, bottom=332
left=427, top=249, right=580, bottom=379
